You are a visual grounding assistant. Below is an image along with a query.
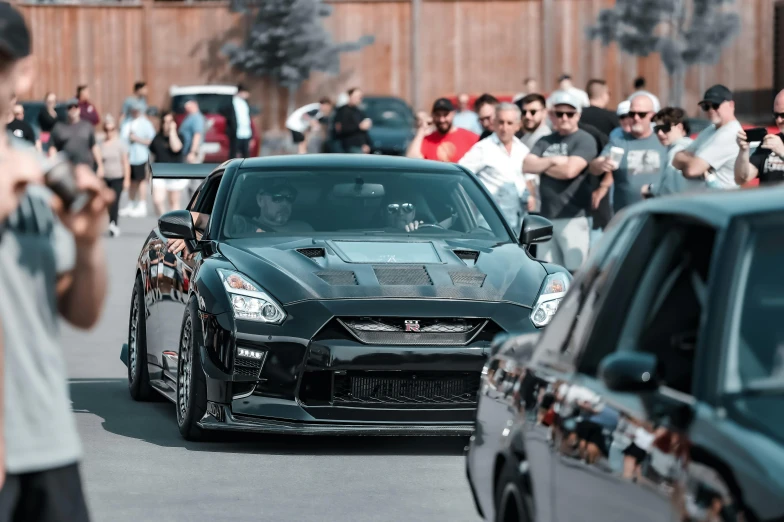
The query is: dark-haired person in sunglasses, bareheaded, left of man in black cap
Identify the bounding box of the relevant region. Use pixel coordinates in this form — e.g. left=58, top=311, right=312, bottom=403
left=641, top=107, right=703, bottom=198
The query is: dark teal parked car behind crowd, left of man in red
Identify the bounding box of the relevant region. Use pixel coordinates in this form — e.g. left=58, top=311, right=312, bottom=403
left=362, top=96, right=416, bottom=156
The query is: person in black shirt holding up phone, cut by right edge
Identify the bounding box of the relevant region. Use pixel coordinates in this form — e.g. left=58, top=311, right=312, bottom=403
left=735, top=90, right=784, bottom=186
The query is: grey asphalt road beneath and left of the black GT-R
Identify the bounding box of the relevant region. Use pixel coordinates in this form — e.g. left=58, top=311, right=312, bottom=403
left=62, top=212, right=478, bottom=522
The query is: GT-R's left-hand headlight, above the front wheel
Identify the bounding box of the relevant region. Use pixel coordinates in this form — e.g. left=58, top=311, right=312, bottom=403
left=217, top=268, right=286, bottom=324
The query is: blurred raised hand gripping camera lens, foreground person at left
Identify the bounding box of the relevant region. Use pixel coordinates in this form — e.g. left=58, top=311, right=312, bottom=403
left=52, top=165, right=115, bottom=245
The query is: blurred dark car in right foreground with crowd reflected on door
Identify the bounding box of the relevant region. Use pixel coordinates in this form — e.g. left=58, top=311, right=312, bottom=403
left=467, top=188, right=784, bottom=522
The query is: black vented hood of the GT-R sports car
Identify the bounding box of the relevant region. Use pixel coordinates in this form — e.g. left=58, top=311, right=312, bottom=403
left=219, top=238, right=547, bottom=307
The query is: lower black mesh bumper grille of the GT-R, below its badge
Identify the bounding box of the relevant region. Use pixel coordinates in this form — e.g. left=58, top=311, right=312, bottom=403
left=333, top=371, right=480, bottom=406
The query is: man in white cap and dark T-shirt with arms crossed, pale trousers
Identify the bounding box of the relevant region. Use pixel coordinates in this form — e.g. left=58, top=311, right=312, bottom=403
left=523, top=91, right=598, bottom=272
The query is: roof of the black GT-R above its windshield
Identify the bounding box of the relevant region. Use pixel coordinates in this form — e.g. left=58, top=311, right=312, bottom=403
left=233, top=154, right=464, bottom=172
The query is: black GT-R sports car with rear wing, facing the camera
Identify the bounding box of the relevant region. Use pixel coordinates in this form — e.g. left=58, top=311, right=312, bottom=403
left=121, top=154, right=571, bottom=439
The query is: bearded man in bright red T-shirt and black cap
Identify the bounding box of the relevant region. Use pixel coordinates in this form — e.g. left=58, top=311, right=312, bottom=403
left=406, top=98, right=479, bottom=163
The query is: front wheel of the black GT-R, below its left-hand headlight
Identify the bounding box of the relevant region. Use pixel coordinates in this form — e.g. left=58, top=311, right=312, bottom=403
left=175, top=300, right=207, bottom=441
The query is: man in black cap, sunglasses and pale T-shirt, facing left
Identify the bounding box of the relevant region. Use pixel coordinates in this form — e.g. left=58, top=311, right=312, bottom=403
left=672, top=85, right=742, bottom=189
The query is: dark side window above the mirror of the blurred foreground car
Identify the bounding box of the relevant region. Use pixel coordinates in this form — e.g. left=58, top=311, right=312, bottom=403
left=580, top=216, right=716, bottom=393
